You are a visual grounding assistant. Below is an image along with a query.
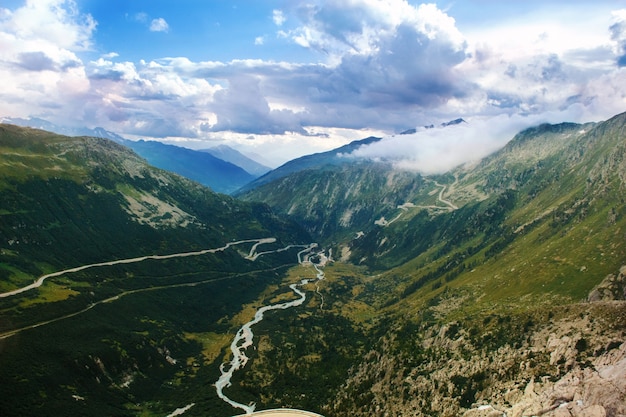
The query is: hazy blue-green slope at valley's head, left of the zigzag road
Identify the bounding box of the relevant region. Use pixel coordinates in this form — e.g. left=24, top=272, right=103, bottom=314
left=240, top=161, right=430, bottom=241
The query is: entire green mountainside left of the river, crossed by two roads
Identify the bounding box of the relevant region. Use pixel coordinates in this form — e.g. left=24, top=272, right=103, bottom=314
left=0, top=125, right=310, bottom=416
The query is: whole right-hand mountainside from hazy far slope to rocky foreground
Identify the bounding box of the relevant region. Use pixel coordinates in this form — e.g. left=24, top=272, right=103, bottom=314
left=241, top=114, right=626, bottom=416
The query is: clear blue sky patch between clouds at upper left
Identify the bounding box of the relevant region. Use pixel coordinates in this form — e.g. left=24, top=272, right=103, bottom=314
left=81, top=0, right=310, bottom=62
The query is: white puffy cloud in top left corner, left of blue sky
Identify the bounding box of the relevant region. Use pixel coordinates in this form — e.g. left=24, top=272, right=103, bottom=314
left=0, top=0, right=96, bottom=119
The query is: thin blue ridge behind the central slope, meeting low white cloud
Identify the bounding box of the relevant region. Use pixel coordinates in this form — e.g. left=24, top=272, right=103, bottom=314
left=236, top=136, right=381, bottom=194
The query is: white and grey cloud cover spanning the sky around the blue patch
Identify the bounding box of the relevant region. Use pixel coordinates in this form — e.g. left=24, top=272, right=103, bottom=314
left=0, top=0, right=626, bottom=166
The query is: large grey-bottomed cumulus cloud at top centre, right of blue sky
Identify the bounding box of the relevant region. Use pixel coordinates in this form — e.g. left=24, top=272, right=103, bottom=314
left=195, top=0, right=467, bottom=132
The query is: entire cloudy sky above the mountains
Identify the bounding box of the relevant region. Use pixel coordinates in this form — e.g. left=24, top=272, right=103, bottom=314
left=0, top=0, right=626, bottom=168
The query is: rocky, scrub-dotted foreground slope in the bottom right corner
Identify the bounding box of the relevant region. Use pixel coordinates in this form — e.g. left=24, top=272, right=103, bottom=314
left=326, top=301, right=626, bottom=417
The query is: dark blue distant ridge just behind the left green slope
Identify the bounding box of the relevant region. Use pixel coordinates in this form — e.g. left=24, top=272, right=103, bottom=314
left=122, top=140, right=256, bottom=194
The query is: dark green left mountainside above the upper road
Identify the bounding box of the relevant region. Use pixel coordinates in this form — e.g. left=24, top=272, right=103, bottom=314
left=0, top=125, right=303, bottom=288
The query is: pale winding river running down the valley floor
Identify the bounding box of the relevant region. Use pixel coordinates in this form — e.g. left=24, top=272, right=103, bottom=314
left=215, top=243, right=327, bottom=415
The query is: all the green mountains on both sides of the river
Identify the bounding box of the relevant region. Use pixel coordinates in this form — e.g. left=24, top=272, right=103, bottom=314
left=0, top=113, right=626, bottom=417
